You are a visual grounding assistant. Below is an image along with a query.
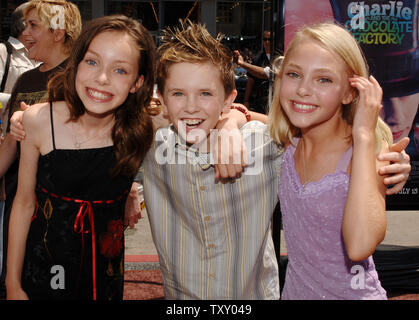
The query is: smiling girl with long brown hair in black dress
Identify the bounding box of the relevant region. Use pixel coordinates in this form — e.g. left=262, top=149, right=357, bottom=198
left=6, top=16, right=155, bottom=299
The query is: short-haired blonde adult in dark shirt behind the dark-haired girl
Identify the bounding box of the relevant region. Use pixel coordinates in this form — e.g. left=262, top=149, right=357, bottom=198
left=0, top=0, right=82, bottom=297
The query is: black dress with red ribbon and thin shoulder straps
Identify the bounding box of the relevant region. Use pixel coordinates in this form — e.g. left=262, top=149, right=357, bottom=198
left=22, top=106, right=133, bottom=300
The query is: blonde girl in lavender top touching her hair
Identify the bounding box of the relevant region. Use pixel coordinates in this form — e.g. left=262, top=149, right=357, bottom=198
left=269, top=23, right=392, bottom=299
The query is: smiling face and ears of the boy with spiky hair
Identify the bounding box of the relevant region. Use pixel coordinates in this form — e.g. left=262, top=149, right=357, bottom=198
left=158, top=61, right=237, bottom=147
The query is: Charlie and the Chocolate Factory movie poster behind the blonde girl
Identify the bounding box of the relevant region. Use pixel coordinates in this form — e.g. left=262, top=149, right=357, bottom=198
left=284, top=0, right=419, bottom=210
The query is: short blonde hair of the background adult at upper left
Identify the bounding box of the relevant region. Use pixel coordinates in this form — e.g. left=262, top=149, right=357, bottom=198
left=23, top=0, right=82, bottom=54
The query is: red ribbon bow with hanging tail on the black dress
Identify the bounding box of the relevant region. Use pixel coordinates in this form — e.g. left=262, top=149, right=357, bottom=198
left=73, top=199, right=96, bottom=300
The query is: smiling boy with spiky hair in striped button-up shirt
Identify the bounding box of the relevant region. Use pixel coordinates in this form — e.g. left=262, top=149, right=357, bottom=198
left=142, top=23, right=282, bottom=299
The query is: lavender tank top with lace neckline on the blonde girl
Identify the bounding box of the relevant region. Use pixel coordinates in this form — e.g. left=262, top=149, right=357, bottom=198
left=278, top=140, right=387, bottom=300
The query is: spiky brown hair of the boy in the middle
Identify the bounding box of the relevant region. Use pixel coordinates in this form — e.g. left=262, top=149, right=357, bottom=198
left=156, top=19, right=236, bottom=96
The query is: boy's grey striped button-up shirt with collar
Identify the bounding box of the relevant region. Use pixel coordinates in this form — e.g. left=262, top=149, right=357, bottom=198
left=140, top=121, right=282, bottom=299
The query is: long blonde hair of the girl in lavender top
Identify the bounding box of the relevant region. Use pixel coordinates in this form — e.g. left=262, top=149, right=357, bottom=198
left=268, top=22, right=393, bottom=153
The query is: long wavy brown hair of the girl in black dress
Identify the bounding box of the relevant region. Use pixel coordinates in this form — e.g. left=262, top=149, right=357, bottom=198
left=48, top=15, right=156, bottom=175
